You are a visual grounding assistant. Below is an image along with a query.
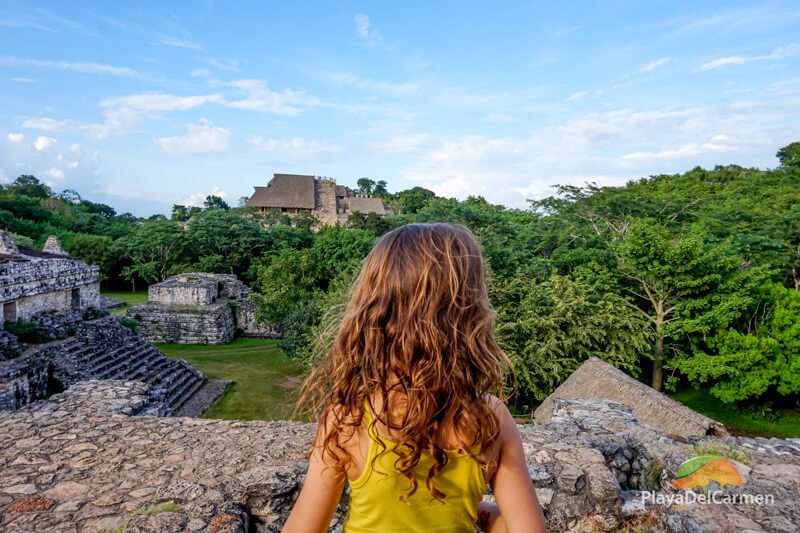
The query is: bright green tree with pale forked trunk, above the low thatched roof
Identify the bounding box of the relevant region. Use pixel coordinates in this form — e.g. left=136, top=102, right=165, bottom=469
left=615, top=219, right=763, bottom=391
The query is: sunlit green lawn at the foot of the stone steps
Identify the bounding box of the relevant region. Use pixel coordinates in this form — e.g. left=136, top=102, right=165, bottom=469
left=156, top=339, right=303, bottom=420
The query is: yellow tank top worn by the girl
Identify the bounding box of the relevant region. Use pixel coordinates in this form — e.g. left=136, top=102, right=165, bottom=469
left=344, top=405, right=486, bottom=533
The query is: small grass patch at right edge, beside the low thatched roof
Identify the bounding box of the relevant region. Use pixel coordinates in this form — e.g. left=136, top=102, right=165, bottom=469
left=670, top=390, right=800, bottom=438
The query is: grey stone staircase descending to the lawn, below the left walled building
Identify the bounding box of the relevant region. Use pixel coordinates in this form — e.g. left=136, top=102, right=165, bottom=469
left=0, top=316, right=212, bottom=416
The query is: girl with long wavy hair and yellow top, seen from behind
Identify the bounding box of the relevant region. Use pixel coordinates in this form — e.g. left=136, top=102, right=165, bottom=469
left=283, top=224, right=545, bottom=533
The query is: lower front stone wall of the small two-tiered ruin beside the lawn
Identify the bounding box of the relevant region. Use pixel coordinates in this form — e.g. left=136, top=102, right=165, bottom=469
left=127, top=300, right=236, bottom=344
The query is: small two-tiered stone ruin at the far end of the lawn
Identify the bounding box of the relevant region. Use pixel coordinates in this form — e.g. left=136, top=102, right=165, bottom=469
left=128, top=272, right=281, bottom=344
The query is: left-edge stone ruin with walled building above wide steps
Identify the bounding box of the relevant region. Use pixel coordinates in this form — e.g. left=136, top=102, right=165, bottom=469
left=0, top=233, right=222, bottom=416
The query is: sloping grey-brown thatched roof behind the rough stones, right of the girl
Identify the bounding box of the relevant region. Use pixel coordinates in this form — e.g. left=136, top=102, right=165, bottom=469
left=534, top=357, right=727, bottom=437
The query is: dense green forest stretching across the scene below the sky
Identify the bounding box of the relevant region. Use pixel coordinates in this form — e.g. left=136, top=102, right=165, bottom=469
left=0, top=143, right=800, bottom=409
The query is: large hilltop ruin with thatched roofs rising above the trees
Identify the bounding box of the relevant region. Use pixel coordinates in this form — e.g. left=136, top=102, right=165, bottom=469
left=246, top=174, right=393, bottom=225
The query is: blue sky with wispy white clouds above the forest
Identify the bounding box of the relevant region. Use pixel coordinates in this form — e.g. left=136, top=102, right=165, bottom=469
left=0, top=1, right=800, bottom=215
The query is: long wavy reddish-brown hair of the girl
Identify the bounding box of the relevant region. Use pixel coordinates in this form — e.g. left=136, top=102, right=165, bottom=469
left=300, top=220, right=510, bottom=500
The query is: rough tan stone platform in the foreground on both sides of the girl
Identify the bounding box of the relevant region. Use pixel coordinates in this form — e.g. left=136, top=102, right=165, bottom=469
left=0, top=381, right=800, bottom=533
